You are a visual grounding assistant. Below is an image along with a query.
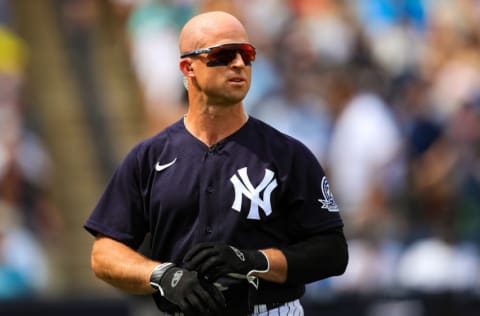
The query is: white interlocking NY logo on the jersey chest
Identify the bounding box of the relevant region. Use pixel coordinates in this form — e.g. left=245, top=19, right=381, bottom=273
left=230, top=167, right=277, bottom=220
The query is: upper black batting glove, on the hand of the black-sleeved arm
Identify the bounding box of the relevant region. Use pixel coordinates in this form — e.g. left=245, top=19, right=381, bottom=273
left=183, top=242, right=270, bottom=287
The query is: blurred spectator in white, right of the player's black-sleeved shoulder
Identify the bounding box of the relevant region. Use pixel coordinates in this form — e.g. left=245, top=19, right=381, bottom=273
left=327, top=67, right=405, bottom=242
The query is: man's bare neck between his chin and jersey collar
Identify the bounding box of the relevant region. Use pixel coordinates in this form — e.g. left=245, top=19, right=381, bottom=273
left=184, top=103, right=248, bottom=147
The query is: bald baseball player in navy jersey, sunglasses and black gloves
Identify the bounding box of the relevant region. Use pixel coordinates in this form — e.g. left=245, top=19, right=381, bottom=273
left=85, top=12, right=348, bottom=315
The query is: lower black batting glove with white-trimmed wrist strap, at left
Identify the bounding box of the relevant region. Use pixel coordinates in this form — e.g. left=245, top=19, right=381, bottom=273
left=150, top=263, right=226, bottom=316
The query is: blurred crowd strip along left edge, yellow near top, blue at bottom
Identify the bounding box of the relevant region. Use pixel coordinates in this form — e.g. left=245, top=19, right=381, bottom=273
left=0, top=1, right=62, bottom=301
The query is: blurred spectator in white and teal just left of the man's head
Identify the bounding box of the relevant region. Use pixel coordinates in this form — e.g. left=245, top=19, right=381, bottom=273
left=113, top=0, right=194, bottom=133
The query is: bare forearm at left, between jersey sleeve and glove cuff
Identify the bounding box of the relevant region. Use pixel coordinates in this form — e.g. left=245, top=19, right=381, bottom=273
left=91, top=236, right=159, bottom=294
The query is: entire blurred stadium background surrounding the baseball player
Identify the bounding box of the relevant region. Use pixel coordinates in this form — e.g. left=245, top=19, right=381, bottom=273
left=0, top=0, right=480, bottom=316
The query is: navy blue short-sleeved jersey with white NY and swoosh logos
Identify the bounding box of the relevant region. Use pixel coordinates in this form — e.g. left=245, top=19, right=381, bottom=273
left=85, top=117, right=343, bottom=264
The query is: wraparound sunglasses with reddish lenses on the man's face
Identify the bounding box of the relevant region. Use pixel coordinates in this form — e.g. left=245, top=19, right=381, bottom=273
left=180, top=43, right=256, bottom=67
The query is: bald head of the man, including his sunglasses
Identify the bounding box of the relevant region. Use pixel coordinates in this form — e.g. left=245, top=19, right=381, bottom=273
left=179, top=11, right=255, bottom=105
